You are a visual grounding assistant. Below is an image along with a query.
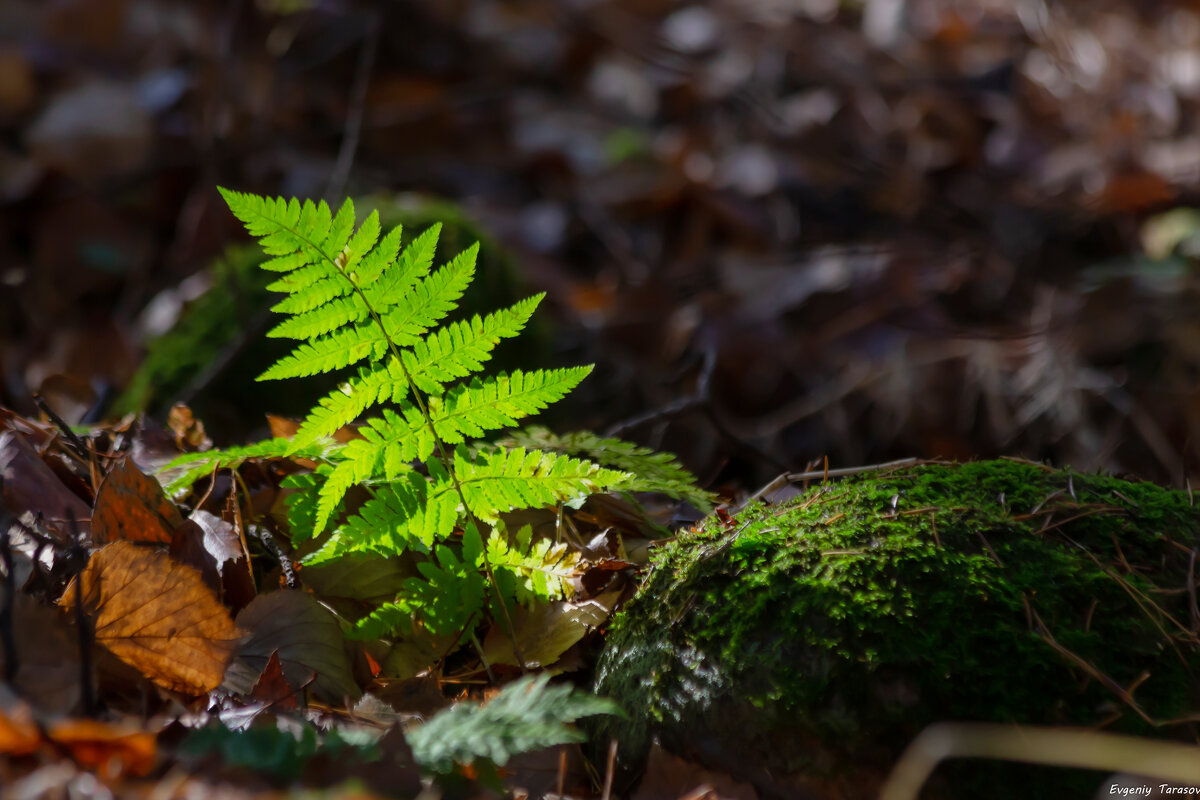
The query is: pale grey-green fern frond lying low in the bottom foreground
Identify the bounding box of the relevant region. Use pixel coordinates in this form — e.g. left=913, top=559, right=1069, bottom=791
left=407, top=674, right=620, bottom=774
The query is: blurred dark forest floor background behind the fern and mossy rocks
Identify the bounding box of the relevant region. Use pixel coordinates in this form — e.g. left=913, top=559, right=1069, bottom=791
left=0, top=0, right=1200, bottom=489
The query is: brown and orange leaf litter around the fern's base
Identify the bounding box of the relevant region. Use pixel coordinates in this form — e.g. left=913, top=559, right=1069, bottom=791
left=0, top=410, right=660, bottom=796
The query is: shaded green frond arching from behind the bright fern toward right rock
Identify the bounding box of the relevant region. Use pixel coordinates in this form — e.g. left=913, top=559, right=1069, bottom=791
left=504, top=426, right=716, bottom=513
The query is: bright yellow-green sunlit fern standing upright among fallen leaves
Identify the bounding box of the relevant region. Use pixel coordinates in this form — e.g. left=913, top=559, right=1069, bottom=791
left=170, top=190, right=648, bottom=657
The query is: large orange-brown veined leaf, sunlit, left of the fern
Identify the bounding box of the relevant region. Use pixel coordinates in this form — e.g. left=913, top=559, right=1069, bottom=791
left=59, top=542, right=240, bottom=694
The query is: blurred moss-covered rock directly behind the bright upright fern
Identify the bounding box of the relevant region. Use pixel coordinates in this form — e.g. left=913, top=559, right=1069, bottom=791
left=115, top=194, right=548, bottom=441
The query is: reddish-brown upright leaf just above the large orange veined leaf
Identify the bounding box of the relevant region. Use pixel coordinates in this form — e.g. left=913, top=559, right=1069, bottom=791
left=91, top=457, right=184, bottom=545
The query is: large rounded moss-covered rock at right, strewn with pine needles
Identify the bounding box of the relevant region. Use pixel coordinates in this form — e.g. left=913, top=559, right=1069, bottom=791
left=594, top=461, right=1200, bottom=798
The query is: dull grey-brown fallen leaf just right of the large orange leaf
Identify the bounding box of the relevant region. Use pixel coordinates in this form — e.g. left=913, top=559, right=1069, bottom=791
left=224, top=589, right=361, bottom=703
